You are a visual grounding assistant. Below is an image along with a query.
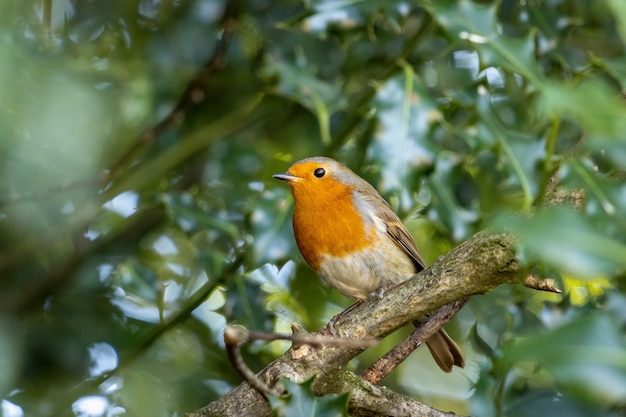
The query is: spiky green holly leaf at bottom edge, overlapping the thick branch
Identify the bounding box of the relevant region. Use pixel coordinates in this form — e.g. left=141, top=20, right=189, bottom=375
left=269, top=378, right=348, bottom=417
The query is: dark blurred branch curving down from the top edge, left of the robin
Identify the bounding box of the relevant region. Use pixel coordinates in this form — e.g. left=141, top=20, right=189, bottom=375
left=108, top=0, right=239, bottom=179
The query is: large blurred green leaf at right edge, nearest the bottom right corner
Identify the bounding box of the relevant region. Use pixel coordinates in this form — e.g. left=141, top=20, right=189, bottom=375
left=503, top=314, right=626, bottom=405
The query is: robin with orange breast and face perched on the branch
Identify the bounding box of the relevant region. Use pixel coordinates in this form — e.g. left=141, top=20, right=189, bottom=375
left=273, top=156, right=465, bottom=372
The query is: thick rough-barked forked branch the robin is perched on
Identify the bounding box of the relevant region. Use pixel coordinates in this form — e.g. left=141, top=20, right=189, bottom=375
left=188, top=232, right=521, bottom=417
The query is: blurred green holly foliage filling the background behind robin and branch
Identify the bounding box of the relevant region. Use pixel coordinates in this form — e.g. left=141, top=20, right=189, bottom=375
left=0, top=0, right=626, bottom=417
